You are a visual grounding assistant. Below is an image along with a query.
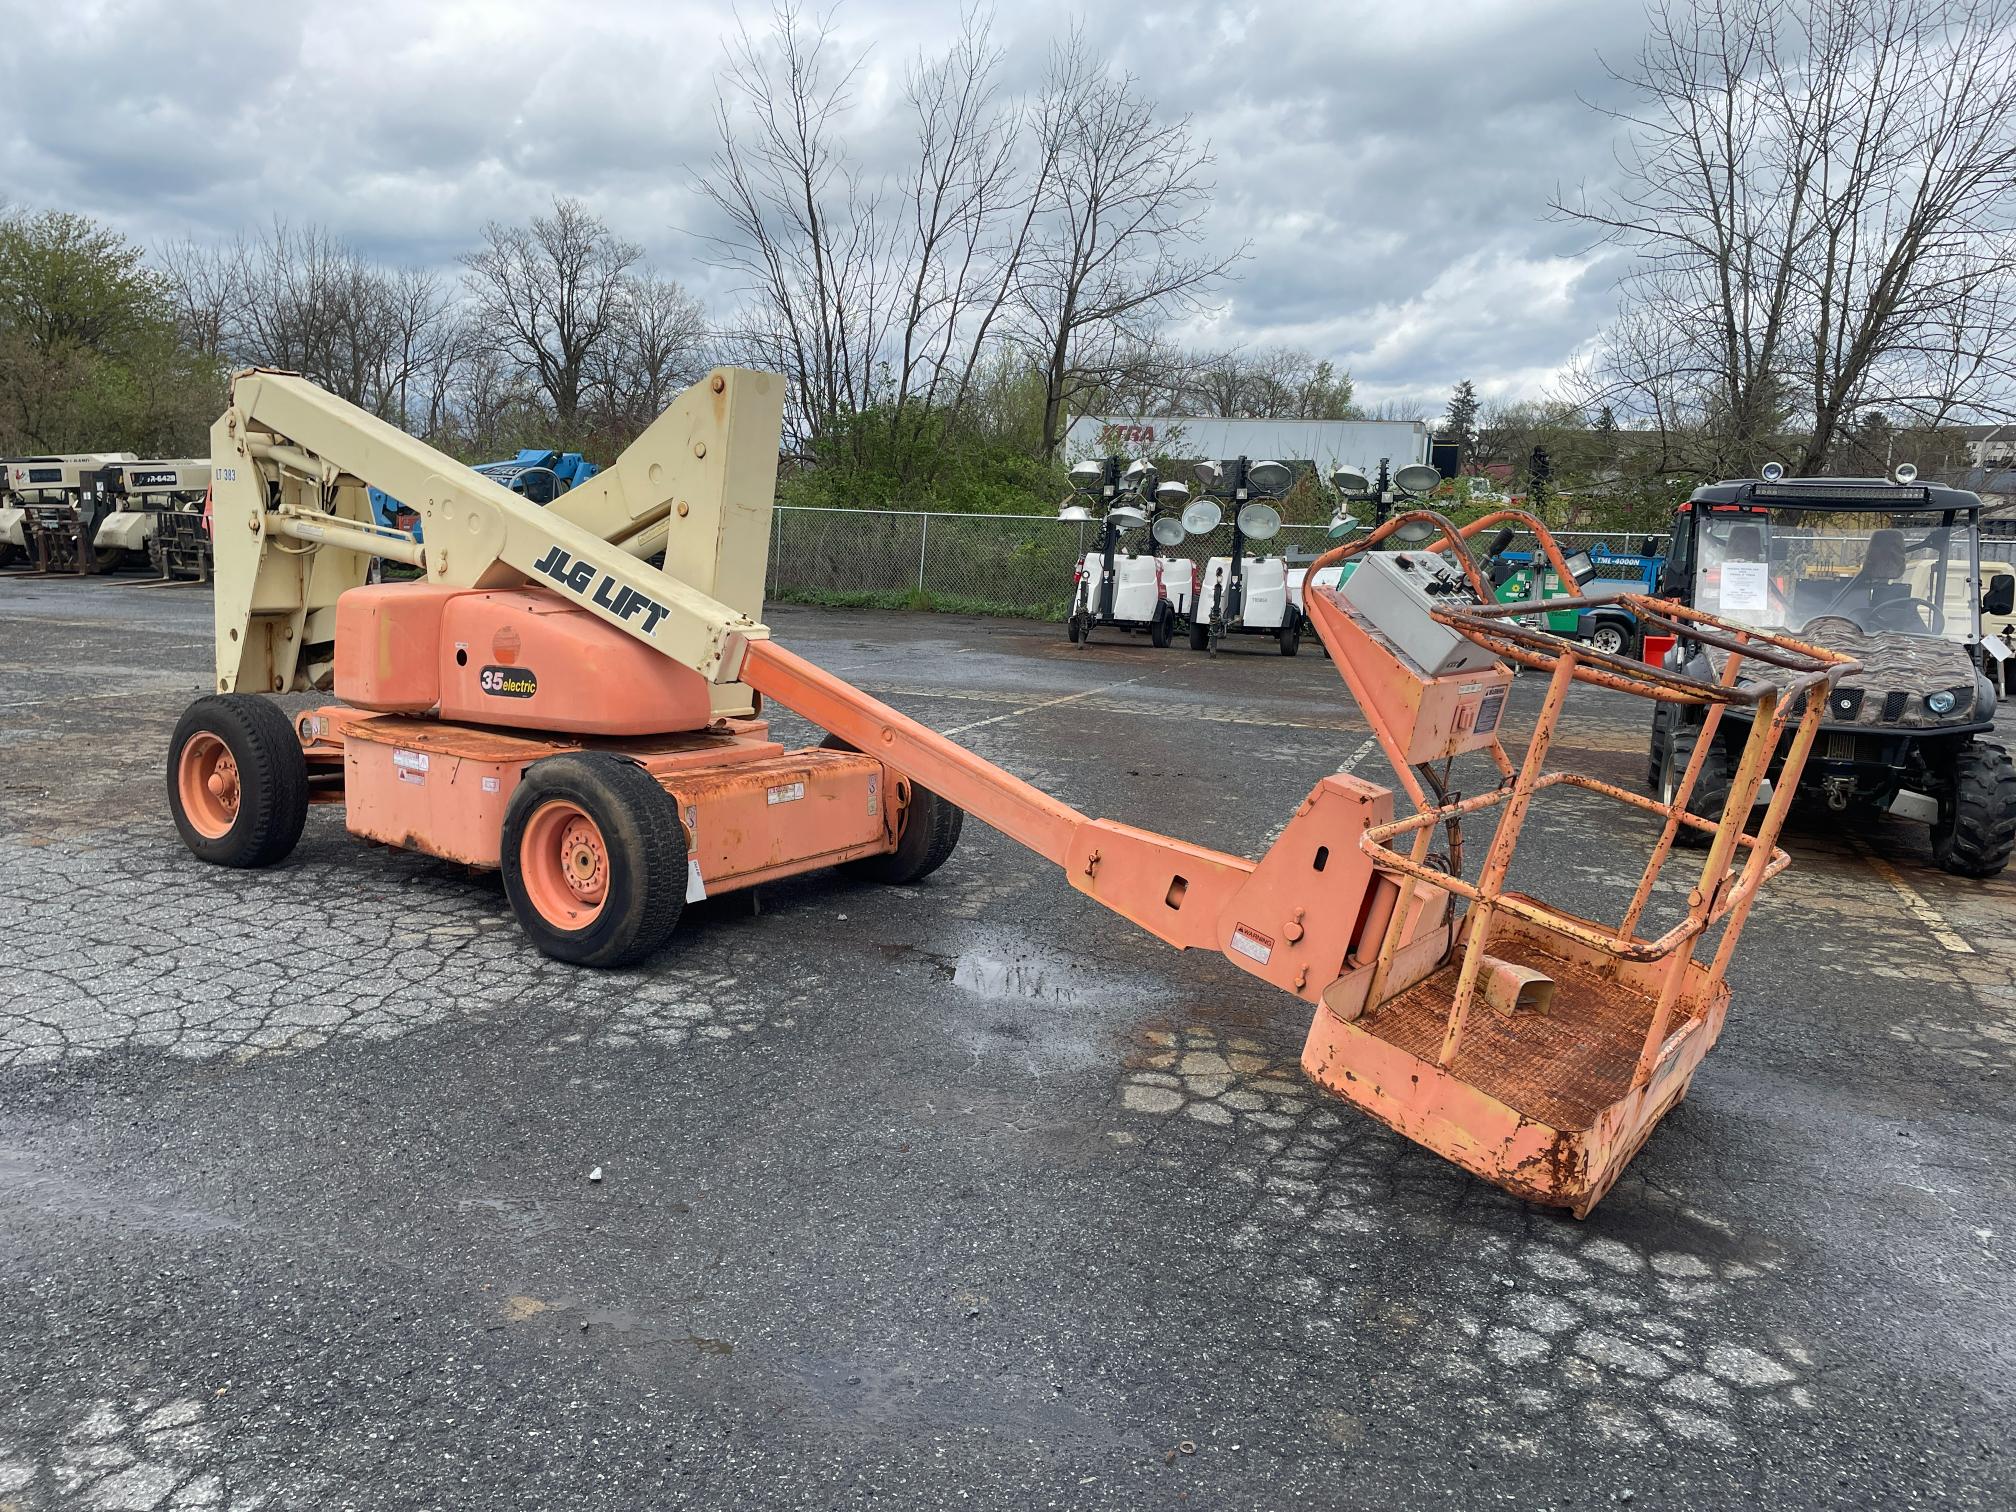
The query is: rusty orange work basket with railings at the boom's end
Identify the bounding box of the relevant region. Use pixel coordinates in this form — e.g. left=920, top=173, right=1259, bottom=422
left=1302, top=510, right=1855, bottom=1216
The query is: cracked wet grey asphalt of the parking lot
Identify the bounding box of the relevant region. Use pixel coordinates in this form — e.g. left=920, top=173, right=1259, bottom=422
left=0, top=577, right=2016, bottom=1512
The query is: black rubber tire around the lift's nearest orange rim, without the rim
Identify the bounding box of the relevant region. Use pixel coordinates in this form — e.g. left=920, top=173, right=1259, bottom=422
left=502, top=750, right=687, bottom=968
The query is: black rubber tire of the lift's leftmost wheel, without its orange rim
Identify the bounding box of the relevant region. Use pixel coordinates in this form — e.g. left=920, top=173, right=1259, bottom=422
left=167, top=694, right=308, bottom=867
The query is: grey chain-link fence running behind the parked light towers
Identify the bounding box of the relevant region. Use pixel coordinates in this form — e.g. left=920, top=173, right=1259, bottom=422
left=770, top=506, right=1665, bottom=619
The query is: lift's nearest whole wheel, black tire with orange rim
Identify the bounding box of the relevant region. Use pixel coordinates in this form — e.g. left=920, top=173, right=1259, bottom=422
left=502, top=752, right=687, bottom=966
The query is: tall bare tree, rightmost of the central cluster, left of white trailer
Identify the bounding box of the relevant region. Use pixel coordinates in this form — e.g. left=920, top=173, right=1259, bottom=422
left=1016, top=32, right=1244, bottom=456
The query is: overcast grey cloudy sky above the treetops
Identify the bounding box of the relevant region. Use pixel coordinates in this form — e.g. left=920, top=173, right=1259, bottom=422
left=0, top=0, right=1643, bottom=415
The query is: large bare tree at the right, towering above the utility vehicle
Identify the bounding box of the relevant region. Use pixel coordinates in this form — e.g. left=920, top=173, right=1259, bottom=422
left=1554, top=0, right=2016, bottom=474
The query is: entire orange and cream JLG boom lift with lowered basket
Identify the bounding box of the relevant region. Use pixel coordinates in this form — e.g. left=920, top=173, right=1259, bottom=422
left=167, top=369, right=1855, bottom=1214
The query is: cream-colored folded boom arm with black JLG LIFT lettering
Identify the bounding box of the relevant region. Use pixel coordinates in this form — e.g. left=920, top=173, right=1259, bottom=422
left=210, top=367, right=784, bottom=714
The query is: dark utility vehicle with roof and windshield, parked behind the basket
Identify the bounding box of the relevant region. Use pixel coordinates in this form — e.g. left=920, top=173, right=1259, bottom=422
left=1647, top=466, right=2016, bottom=877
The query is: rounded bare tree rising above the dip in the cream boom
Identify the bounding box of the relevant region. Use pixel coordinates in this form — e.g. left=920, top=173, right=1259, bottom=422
left=462, top=200, right=643, bottom=435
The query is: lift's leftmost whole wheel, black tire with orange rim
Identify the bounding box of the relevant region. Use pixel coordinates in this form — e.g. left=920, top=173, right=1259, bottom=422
left=167, top=694, right=308, bottom=867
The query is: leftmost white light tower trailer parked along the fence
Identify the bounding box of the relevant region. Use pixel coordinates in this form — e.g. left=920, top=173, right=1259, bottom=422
left=1058, top=458, right=1198, bottom=647
